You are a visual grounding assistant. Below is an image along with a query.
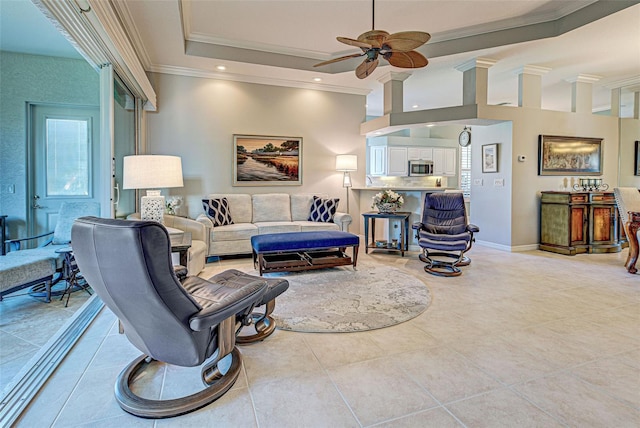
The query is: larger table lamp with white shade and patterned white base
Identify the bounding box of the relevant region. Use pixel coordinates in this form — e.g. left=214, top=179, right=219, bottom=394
left=122, top=155, right=184, bottom=223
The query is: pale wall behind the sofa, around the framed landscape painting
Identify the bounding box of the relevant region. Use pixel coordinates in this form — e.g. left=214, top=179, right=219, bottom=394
left=146, top=73, right=366, bottom=226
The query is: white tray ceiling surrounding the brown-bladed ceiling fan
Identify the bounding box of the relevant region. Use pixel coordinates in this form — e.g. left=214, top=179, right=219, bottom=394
left=0, top=0, right=640, bottom=115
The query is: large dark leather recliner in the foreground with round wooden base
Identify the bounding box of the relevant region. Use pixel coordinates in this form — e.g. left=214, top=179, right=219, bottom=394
left=71, top=217, right=267, bottom=418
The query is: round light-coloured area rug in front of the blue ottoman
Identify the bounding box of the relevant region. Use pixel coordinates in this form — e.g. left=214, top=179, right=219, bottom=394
left=255, top=264, right=431, bottom=333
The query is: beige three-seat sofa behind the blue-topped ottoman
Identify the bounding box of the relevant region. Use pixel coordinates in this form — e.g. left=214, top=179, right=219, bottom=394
left=196, top=193, right=352, bottom=256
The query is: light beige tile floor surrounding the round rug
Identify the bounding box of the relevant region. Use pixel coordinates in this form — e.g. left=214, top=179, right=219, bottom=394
left=11, top=246, right=640, bottom=428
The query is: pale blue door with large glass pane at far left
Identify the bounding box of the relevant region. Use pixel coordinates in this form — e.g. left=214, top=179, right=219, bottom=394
left=29, top=104, right=100, bottom=243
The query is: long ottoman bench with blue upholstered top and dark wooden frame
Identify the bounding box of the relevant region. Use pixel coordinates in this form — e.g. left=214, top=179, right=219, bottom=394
left=251, top=230, right=360, bottom=275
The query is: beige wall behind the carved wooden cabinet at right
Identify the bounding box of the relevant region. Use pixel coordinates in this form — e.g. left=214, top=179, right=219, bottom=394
left=471, top=106, right=640, bottom=250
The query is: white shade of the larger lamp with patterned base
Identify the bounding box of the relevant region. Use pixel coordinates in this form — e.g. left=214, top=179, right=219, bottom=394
left=122, top=155, right=184, bottom=189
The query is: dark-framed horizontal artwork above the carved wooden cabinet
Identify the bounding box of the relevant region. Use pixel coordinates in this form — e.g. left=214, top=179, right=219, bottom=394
left=538, top=135, right=602, bottom=175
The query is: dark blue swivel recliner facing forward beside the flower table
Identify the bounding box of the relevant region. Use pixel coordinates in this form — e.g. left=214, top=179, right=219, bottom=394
left=412, top=192, right=480, bottom=276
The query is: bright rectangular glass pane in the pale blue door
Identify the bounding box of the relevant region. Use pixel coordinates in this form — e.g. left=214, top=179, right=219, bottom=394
left=46, top=118, right=90, bottom=196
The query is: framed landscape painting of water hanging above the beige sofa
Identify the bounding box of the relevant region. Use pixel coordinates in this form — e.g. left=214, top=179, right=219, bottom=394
left=233, top=135, right=302, bottom=186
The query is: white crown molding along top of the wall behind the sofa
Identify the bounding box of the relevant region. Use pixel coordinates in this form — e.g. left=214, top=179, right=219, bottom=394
left=149, top=64, right=371, bottom=95
